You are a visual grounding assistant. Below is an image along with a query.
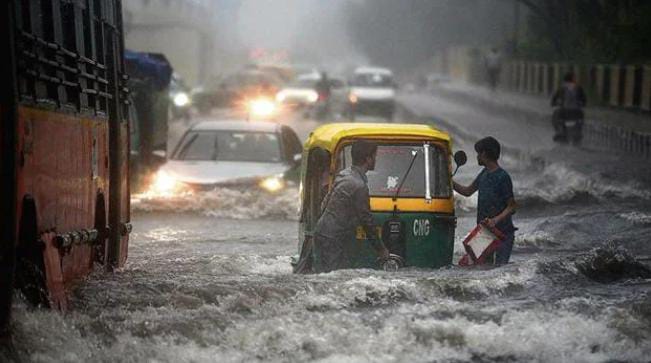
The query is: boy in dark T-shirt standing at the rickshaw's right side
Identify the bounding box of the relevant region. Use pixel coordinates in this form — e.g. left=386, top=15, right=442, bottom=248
left=452, top=136, right=517, bottom=265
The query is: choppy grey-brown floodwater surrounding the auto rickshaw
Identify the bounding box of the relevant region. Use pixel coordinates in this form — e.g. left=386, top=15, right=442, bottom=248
left=0, top=95, right=651, bottom=362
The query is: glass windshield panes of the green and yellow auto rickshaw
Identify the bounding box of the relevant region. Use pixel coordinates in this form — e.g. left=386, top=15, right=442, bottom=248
left=338, top=144, right=451, bottom=198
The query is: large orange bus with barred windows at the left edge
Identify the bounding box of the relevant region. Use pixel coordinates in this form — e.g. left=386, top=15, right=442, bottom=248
left=0, top=0, right=131, bottom=331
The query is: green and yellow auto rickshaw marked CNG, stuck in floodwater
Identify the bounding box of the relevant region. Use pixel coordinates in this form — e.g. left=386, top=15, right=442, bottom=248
left=293, top=123, right=466, bottom=273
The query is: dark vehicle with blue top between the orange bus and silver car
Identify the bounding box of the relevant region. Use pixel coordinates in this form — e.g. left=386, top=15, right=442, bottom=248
left=124, top=50, right=173, bottom=190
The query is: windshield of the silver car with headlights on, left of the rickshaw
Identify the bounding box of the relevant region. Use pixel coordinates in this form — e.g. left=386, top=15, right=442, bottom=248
left=174, top=131, right=281, bottom=162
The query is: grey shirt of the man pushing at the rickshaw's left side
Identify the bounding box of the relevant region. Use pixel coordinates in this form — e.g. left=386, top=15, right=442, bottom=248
left=315, top=165, right=376, bottom=244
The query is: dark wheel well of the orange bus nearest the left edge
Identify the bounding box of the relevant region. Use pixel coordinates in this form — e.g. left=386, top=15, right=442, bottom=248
left=15, top=195, right=49, bottom=306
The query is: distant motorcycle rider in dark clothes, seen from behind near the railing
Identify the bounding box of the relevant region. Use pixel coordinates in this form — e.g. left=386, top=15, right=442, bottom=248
left=551, top=72, right=587, bottom=141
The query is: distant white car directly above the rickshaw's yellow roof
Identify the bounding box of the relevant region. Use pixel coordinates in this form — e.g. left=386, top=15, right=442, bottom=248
left=347, top=67, right=396, bottom=120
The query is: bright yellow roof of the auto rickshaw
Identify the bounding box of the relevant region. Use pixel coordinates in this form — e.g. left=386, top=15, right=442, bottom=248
left=305, top=122, right=450, bottom=152
